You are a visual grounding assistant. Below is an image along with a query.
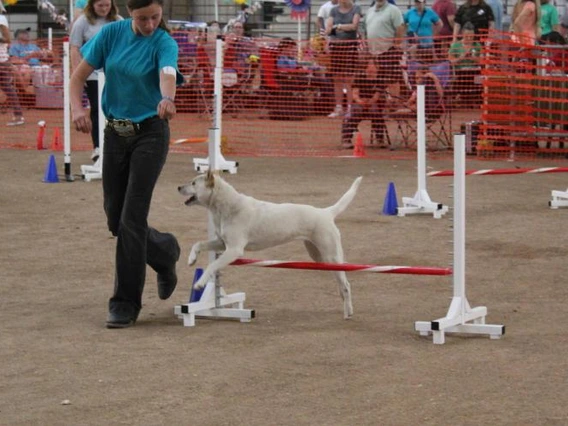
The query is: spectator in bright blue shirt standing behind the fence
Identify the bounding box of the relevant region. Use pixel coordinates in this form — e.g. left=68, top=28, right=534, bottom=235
left=404, top=0, right=442, bottom=62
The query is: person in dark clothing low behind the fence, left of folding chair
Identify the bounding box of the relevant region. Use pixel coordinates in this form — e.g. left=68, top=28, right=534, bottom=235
left=341, top=57, right=387, bottom=149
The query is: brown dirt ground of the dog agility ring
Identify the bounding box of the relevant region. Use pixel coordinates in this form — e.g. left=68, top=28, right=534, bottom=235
left=0, top=150, right=568, bottom=426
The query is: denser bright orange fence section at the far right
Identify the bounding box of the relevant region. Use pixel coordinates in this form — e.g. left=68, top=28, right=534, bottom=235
left=477, top=32, right=568, bottom=159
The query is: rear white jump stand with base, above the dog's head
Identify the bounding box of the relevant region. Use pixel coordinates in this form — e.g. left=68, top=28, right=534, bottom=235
left=193, top=35, right=239, bottom=174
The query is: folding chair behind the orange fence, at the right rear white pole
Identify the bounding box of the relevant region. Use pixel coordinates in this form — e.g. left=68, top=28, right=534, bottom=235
left=386, top=61, right=452, bottom=149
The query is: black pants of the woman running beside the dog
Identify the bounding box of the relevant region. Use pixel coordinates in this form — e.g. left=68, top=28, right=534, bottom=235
left=103, top=118, right=177, bottom=315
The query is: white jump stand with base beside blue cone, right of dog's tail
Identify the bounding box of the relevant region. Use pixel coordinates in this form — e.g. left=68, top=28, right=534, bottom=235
left=398, top=84, right=448, bottom=219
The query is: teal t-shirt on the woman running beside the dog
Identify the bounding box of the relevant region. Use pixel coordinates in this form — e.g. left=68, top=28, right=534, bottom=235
left=81, top=18, right=183, bottom=123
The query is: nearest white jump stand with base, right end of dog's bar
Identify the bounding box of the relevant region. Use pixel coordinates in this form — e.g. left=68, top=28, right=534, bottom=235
left=414, top=135, right=505, bottom=344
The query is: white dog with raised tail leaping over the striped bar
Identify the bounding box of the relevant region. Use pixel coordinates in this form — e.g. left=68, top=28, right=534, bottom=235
left=178, top=172, right=362, bottom=319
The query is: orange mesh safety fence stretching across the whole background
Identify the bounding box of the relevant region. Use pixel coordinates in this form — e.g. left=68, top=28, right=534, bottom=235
left=0, top=32, right=568, bottom=159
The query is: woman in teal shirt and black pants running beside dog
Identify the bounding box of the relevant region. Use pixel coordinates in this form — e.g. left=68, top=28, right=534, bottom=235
left=70, top=0, right=182, bottom=328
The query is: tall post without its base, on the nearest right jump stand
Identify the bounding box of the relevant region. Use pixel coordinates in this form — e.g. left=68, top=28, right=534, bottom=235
left=453, top=135, right=466, bottom=317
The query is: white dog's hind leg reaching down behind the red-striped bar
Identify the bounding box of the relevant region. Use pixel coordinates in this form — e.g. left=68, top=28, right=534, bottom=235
left=304, top=228, right=353, bottom=319
